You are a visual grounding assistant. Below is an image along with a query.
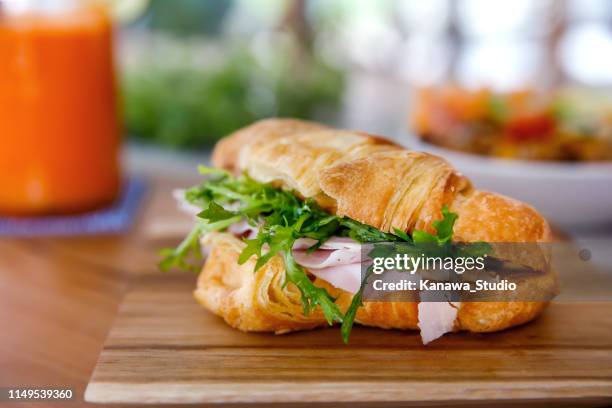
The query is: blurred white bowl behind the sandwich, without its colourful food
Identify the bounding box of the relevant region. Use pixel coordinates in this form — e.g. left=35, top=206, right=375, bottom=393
left=411, top=139, right=612, bottom=228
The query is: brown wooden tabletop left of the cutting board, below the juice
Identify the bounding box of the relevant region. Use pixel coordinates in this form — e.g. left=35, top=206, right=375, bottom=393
left=0, top=176, right=195, bottom=407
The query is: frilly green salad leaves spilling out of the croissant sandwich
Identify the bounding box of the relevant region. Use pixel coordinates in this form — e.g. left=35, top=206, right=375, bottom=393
left=160, top=166, right=457, bottom=343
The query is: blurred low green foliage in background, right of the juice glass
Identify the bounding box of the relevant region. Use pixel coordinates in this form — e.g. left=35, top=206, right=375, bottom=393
left=121, top=44, right=343, bottom=148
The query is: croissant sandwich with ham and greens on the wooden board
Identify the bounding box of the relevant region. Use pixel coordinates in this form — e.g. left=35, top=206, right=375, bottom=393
left=162, top=119, right=551, bottom=343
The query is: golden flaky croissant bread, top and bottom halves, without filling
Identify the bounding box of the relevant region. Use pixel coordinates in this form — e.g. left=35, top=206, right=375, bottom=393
left=170, top=119, right=551, bottom=344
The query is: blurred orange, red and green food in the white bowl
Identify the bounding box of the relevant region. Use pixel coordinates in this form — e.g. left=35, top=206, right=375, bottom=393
left=411, top=85, right=612, bottom=161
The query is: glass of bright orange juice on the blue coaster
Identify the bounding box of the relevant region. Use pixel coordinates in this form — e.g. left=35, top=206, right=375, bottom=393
left=0, top=0, right=120, bottom=215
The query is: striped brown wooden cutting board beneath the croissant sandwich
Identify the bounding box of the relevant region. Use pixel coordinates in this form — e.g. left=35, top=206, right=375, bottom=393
left=85, top=274, right=612, bottom=406
